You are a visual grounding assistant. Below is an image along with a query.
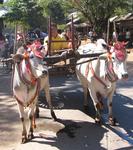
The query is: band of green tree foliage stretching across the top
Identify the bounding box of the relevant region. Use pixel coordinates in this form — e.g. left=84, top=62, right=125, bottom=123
left=2, top=0, right=133, bottom=32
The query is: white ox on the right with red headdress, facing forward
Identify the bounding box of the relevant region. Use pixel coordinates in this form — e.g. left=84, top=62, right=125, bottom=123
left=76, top=39, right=128, bottom=125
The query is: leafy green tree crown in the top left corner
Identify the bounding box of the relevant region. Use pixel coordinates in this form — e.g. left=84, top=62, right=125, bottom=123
left=6, top=0, right=46, bottom=29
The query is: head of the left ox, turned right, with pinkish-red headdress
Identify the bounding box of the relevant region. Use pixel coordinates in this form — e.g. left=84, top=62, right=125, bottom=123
left=13, top=42, right=48, bottom=80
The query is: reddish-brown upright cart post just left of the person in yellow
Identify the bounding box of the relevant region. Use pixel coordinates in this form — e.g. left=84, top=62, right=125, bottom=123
left=48, top=17, right=52, bottom=55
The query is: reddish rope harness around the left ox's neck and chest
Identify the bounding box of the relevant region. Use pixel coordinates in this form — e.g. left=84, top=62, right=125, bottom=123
left=14, top=53, right=40, bottom=107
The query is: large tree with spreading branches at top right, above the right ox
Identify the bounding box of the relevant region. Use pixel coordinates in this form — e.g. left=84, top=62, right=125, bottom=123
left=69, top=0, right=128, bottom=33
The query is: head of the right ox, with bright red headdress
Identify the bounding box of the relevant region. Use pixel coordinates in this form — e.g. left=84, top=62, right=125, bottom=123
left=110, top=42, right=128, bottom=79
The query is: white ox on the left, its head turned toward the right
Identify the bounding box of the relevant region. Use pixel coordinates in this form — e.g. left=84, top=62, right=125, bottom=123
left=13, top=43, right=56, bottom=143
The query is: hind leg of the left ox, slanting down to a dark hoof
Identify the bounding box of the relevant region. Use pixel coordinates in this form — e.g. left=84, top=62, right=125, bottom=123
left=44, top=87, right=57, bottom=121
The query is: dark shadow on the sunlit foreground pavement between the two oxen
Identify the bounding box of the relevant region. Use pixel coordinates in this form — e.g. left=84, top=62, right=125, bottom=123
left=31, top=120, right=108, bottom=150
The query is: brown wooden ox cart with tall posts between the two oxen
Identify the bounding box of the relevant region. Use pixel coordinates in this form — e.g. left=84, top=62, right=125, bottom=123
left=44, top=16, right=102, bottom=75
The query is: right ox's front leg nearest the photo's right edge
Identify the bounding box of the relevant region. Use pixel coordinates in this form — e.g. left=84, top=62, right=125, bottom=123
left=107, top=92, right=116, bottom=126
